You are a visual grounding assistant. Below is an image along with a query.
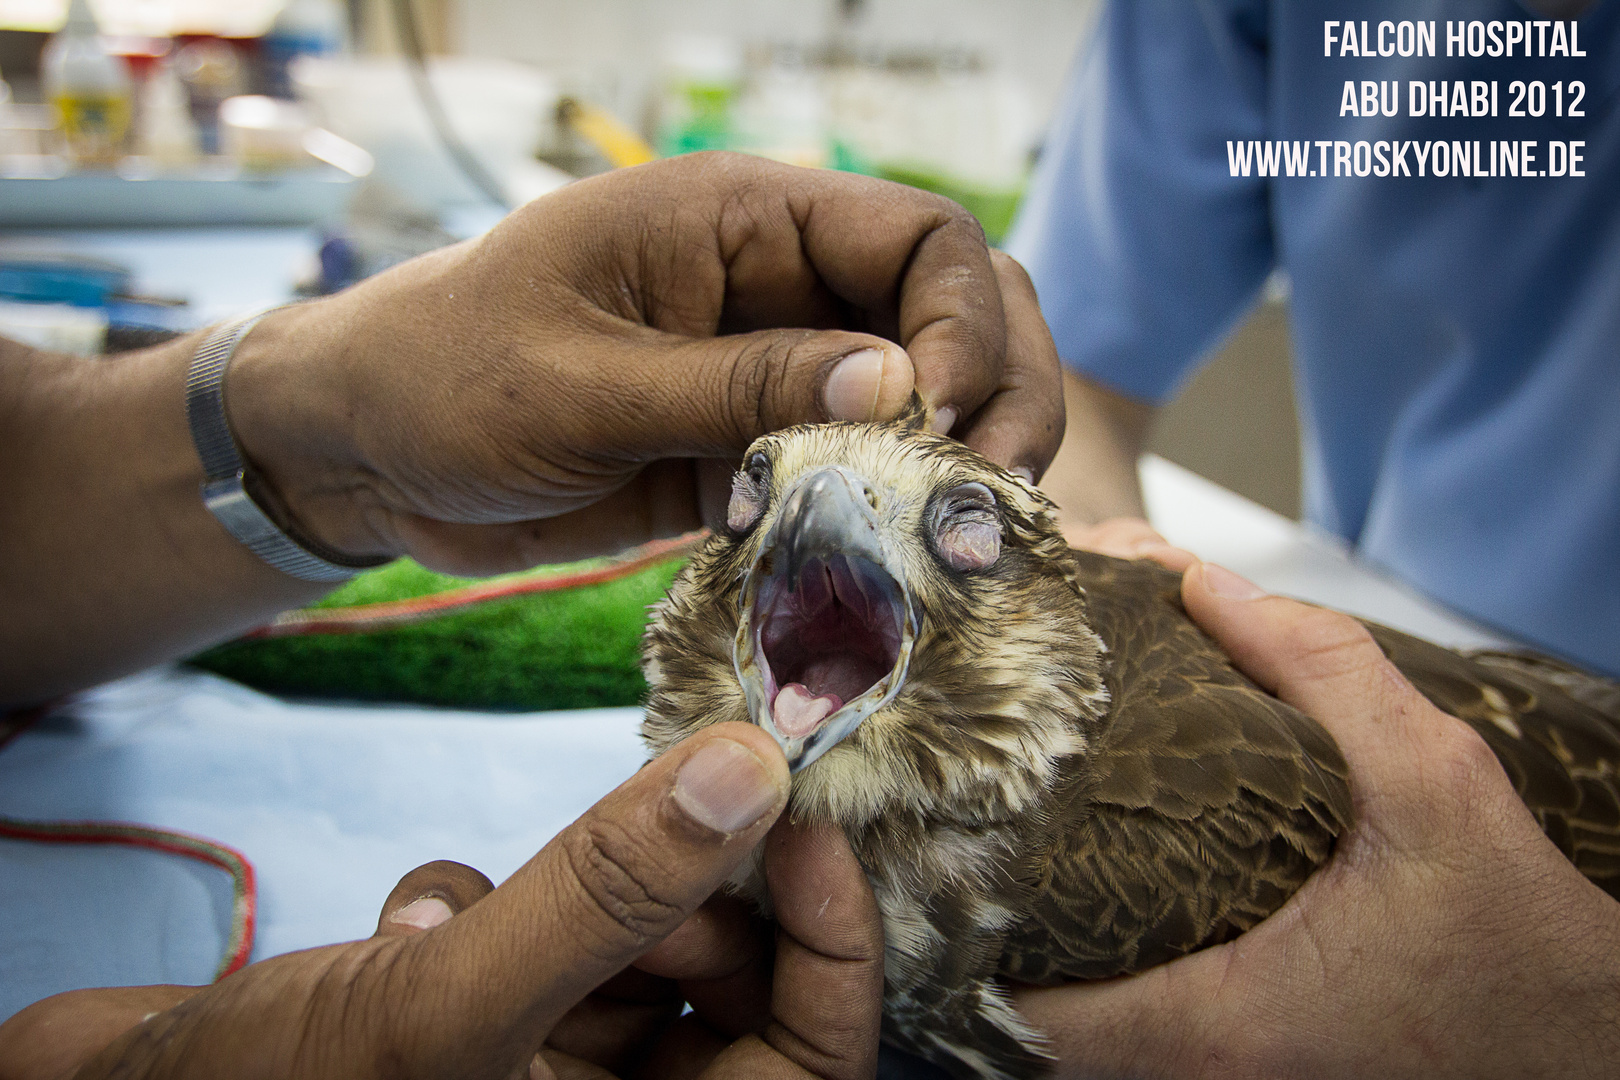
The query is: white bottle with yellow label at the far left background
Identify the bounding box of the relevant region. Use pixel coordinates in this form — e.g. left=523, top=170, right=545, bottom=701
left=39, top=0, right=131, bottom=165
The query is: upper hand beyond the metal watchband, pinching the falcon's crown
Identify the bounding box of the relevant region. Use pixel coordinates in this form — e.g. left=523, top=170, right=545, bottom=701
left=227, top=154, right=1063, bottom=573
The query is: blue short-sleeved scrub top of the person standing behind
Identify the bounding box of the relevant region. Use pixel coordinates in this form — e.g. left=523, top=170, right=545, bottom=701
left=1008, top=0, right=1620, bottom=675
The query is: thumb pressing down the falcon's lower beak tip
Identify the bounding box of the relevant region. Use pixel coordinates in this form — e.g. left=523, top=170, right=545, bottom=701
left=387, top=724, right=789, bottom=1075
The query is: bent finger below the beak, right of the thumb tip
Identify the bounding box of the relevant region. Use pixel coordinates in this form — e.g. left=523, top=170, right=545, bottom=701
left=705, top=823, right=883, bottom=1078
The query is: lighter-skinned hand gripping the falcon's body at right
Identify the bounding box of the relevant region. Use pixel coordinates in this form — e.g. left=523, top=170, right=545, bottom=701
left=1017, top=563, right=1620, bottom=1078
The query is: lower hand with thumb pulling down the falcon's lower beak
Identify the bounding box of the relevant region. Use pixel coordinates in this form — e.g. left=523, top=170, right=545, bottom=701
left=0, top=724, right=883, bottom=1080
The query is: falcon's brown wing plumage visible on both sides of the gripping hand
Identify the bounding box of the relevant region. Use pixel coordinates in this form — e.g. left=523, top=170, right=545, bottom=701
left=1001, top=552, right=1620, bottom=983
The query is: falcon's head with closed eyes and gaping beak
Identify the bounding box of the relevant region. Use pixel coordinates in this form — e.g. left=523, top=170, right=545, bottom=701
left=643, top=410, right=1106, bottom=827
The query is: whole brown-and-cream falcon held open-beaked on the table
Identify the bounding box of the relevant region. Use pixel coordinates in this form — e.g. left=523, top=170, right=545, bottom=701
left=643, top=410, right=1620, bottom=1078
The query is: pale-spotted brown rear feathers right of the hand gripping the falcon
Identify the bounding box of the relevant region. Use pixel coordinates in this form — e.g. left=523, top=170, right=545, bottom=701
left=1367, top=623, right=1620, bottom=899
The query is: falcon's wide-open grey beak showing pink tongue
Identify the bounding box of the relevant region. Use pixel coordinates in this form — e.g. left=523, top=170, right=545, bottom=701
left=732, top=465, right=917, bottom=772
